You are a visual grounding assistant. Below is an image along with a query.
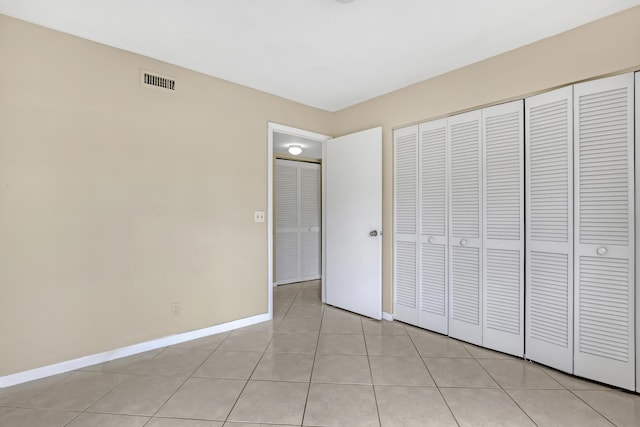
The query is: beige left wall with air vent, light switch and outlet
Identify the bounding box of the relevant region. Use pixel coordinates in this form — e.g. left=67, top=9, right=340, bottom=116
left=0, top=15, right=332, bottom=376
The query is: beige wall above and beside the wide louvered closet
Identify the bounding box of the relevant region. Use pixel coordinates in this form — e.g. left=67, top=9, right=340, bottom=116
left=333, top=7, right=640, bottom=312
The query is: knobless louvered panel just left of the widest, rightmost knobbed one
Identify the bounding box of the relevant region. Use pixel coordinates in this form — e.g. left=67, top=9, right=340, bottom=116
left=525, top=87, right=573, bottom=373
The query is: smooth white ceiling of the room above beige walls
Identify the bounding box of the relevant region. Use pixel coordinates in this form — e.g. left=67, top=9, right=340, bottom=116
left=0, top=0, right=640, bottom=111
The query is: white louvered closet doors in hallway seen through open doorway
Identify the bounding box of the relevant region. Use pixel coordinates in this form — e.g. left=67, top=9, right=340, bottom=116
left=275, top=159, right=321, bottom=285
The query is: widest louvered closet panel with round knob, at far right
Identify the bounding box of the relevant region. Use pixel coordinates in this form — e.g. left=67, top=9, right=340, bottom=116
left=574, top=74, right=635, bottom=390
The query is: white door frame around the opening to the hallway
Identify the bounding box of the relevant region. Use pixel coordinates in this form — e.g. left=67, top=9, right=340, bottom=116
left=267, top=122, right=331, bottom=319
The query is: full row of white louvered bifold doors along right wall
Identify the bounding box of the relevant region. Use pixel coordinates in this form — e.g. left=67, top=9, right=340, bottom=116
left=394, top=73, right=640, bottom=390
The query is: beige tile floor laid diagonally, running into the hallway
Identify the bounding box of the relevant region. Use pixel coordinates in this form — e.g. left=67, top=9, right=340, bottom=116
left=0, top=282, right=640, bottom=427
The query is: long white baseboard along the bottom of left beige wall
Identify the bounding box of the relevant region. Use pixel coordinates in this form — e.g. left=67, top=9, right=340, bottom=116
left=0, top=313, right=270, bottom=389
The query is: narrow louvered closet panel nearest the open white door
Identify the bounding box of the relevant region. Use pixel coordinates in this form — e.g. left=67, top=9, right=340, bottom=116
left=393, top=125, right=419, bottom=325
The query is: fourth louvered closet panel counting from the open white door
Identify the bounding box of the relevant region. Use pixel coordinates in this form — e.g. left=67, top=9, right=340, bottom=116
left=482, top=100, right=524, bottom=357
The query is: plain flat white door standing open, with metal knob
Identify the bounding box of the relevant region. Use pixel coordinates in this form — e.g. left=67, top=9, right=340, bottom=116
left=322, top=128, right=382, bottom=319
